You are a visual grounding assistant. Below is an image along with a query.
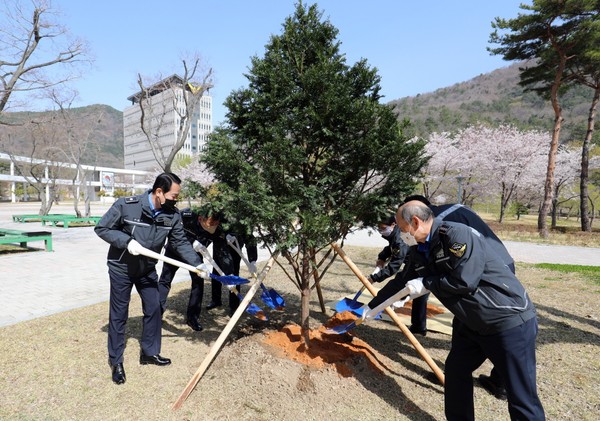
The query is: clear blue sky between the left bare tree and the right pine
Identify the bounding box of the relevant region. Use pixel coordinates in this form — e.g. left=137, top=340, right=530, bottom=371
left=47, top=0, right=528, bottom=126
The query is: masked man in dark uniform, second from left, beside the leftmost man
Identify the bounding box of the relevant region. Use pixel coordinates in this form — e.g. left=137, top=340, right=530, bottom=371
left=158, top=206, right=221, bottom=332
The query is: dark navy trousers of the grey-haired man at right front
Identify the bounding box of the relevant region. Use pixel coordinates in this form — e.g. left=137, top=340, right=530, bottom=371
left=444, top=317, right=545, bottom=421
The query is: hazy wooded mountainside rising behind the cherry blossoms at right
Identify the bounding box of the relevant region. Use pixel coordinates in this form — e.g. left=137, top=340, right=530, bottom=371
left=389, top=63, right=593, bottom=142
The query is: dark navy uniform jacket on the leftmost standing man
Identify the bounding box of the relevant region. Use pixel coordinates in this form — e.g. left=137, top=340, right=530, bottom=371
left=94, top=191, right=202, bottom=277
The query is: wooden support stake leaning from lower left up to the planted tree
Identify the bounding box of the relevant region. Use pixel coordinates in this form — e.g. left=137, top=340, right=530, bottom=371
left=172, top=252, right=279, bottom=410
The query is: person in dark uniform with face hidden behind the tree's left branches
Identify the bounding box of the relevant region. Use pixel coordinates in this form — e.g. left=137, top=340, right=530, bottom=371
left=206, top=223, right=258, bottom=316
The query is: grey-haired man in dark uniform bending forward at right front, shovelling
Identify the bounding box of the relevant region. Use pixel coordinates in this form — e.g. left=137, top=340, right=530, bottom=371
left=386, top=201, right=545, bottom=421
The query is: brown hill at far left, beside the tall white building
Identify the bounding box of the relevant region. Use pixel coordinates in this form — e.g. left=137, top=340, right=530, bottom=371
left=0, top=105, right=123, bottom=168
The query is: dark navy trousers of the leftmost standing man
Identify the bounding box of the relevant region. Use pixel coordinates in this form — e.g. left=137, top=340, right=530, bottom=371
left=108, top=269, right=162, bottom=365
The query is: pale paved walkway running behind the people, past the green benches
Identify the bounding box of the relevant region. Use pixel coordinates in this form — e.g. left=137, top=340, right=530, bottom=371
left=0, top=203, right=600, bottom=327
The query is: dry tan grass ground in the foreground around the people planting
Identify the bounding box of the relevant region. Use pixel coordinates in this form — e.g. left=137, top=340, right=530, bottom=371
left=0, top=247, right=600, bottom=421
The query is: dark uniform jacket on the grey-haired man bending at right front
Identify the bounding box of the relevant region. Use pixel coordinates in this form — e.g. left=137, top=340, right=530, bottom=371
left=407, top=219, right=535, bottom=335
